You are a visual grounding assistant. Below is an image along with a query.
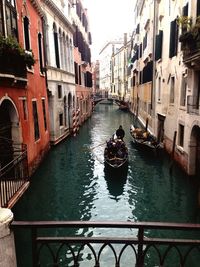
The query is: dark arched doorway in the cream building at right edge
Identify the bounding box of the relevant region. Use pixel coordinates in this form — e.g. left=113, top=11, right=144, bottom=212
left=189, top=125, right=200, bottom=177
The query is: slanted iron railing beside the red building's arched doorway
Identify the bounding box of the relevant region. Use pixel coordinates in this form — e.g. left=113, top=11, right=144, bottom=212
left=0, top=144, right=29, bottom=207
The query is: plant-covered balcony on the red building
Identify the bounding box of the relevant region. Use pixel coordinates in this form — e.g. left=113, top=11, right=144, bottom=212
left=0, top=36, right=35, bottom=87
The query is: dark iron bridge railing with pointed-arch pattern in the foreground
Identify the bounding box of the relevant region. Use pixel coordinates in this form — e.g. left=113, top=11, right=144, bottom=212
left=11, top=221, right=200, bottom=267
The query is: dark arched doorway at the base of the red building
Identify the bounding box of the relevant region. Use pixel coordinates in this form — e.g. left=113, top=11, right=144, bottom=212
left=0, top=99, right=20, bottom=168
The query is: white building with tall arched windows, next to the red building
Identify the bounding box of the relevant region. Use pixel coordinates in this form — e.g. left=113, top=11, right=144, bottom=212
left=41, top=0, right=76, bottom=144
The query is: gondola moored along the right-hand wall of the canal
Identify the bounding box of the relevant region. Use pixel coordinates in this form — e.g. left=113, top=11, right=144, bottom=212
left=130, top=125, right=162, bottom=152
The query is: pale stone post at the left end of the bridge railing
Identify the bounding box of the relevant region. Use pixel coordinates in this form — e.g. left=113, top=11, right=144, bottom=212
left=0, top=207, right=17, bottom=267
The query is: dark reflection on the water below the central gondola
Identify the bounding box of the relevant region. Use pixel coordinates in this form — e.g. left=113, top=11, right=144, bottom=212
left=104, top=165, right=128, bottom=201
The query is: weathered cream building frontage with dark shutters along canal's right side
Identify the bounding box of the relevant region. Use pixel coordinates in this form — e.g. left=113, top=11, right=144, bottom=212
left=131, top=0, right=200, bottom=175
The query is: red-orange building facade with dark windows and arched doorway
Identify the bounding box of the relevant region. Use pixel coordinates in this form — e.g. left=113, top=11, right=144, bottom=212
left=0, top=0, right=49, bottom=174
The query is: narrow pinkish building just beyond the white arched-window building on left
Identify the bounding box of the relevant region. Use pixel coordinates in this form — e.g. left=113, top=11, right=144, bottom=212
left=72, top=0, right=93, bottom=127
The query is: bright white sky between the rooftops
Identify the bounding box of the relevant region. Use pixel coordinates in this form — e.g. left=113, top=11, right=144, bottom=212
left=82, top=0, right=135, bottom=61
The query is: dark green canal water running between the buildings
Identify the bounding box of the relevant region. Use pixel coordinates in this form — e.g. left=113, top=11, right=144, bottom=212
left=12, top=104, right=200, bottom=267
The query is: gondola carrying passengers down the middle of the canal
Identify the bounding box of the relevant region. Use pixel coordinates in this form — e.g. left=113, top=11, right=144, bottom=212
left=104, top=137, right=128, bottom=169
